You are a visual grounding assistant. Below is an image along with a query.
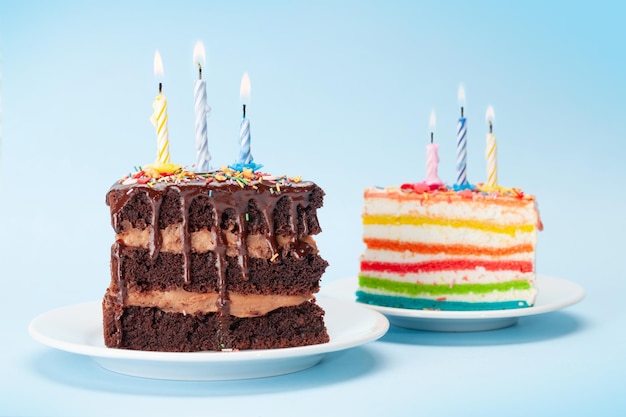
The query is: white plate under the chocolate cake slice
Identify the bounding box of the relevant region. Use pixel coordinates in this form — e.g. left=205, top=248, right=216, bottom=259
left=28, top=296, right=389, bottom=381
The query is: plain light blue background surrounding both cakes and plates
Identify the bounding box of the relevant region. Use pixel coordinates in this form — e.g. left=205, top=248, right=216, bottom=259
left=0, top=0, right=626, bottom=415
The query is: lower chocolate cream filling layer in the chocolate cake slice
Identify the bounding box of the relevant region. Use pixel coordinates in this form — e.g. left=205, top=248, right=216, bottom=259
left=126, top=289, right=314, bottom=318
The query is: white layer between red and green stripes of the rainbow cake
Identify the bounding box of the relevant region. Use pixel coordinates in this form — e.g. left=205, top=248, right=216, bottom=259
left=359, top=267, right=535, bottom=285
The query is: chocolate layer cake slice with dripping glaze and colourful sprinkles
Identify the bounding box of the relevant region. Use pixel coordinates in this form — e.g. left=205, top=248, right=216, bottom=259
left=103, top=168, right=329, bottom=352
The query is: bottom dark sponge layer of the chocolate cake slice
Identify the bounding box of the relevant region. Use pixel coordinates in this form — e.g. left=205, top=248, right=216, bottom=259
left=103, top=297, right=329, bottom=352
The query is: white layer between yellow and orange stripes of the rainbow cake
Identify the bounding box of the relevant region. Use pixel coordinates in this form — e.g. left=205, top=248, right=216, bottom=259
left=363, top=224, right=537, bottom=248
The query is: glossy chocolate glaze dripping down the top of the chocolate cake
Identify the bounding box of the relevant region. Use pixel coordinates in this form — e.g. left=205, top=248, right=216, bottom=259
left=106, top=180, right=324, bottom=346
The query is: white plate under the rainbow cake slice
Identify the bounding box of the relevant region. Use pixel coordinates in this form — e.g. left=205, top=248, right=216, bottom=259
left=322, top=275, right=585, bottom=332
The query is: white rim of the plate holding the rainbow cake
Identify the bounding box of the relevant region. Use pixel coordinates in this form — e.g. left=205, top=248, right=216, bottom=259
left=324, top=274, right=586, bottom=320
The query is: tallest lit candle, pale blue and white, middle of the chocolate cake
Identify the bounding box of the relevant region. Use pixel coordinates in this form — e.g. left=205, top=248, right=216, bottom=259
left=193, top=41, right=211, bottom=172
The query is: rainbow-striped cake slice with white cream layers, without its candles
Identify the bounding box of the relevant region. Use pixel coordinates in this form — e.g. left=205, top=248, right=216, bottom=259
left=357, top=183, right=542, bottom=310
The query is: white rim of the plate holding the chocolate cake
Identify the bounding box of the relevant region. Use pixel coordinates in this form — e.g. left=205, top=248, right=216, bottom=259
left=28, top=295, right=390, bottom=363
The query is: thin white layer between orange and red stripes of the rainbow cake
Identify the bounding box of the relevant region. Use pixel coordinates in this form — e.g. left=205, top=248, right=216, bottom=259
left=361, top=249, right=535, bottom=264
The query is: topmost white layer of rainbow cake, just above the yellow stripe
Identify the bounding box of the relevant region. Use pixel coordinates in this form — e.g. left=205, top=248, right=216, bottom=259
left=363, top=197, right=538, bottom=225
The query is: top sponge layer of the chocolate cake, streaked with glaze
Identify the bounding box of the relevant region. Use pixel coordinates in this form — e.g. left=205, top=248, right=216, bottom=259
left=107, top=179, right=324, bottom=236
